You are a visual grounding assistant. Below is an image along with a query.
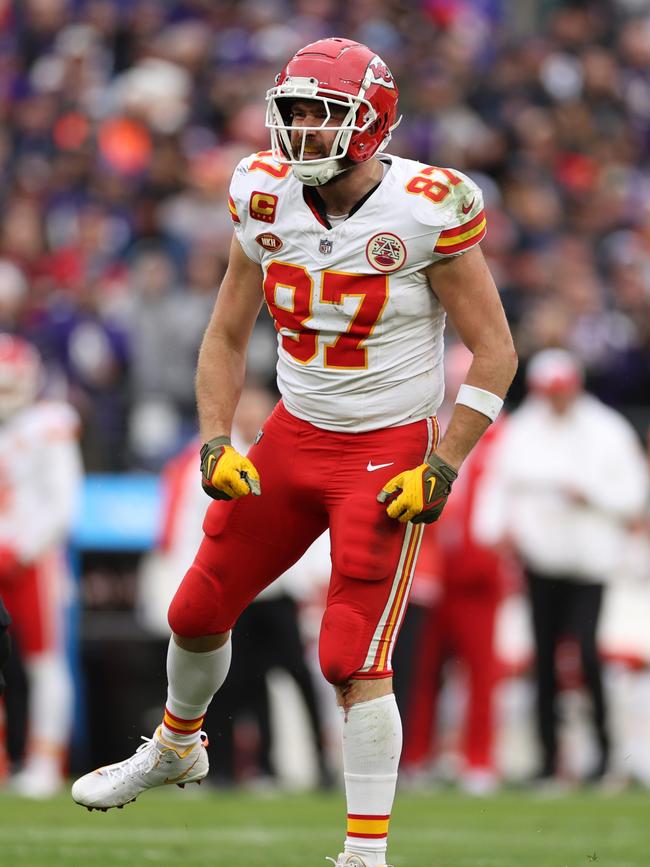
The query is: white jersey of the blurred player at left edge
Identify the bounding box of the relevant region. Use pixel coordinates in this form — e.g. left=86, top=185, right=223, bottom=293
left=0, top=401, right=82, bottom=563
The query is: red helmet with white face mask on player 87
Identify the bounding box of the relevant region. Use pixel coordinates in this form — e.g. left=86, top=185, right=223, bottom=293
left=266, top=37, right=399, bottom=186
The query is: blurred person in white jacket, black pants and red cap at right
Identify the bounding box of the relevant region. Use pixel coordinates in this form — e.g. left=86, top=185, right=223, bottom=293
left=476, top=349, right=648, bottom=782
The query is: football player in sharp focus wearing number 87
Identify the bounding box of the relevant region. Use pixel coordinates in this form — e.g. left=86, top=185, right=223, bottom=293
left=72, top=38, right=516, bottom=867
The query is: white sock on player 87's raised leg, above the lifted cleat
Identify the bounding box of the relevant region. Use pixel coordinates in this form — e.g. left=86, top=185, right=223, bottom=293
left=162, top=637, right=232, bottom=747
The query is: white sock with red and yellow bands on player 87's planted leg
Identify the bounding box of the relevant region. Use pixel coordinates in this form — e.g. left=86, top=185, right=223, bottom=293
left=341, top=694, right=402, bottom=867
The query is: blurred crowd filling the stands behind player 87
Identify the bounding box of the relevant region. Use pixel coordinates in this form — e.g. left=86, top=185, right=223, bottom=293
left=0, top=0, right=650, bottom=471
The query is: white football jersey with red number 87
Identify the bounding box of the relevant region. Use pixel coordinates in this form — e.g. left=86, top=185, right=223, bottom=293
left=229, top=152, right=485, bottom=431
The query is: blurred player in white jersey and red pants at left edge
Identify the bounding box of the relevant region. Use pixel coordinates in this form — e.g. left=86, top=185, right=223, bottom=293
left=0, top=334, right=82, bottom=798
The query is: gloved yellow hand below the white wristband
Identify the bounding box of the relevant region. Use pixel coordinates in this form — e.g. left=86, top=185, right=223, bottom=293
left=377, top=454, right=458, bottom=524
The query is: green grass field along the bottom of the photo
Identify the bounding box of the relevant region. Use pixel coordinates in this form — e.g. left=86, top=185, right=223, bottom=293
left=0, top=787, right=650, bottom=867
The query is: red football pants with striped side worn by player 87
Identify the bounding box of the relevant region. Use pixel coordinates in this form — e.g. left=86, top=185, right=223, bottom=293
left=169, top=402, right=437, bottom=683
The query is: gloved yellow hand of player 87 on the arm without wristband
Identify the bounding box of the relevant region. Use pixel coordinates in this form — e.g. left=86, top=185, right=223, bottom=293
left=201, top=437, right=262, bottom=500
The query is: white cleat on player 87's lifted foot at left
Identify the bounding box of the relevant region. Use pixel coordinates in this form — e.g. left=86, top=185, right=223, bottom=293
left=72, top=727, right=209, bottom=811
